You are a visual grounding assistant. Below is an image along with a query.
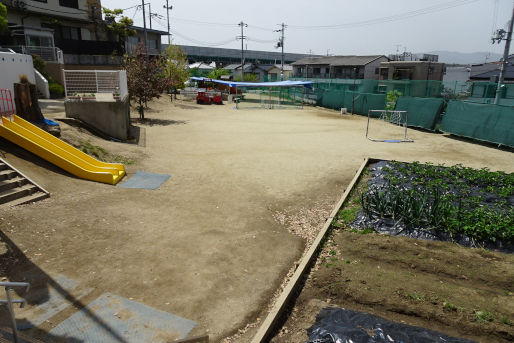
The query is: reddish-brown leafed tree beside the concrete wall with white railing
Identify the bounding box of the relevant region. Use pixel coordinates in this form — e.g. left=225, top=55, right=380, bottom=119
left=123, top=44, right=168, bottom=119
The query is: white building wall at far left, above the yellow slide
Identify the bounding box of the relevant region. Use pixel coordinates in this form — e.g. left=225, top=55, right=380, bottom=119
left=0, top=52, right=36, bottom=110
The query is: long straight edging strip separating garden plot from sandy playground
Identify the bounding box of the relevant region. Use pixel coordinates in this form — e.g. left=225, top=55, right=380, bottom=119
left=251, top=157, right=378, bottom=343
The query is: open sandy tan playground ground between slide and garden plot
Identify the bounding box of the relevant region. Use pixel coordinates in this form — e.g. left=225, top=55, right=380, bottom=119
left=0, top=98, right=514, bottom=342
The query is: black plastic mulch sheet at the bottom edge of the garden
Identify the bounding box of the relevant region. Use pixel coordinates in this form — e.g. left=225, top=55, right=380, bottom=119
left=307, top=307, right=473, bottom=343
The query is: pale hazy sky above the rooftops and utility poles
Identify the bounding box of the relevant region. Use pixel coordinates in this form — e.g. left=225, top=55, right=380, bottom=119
left=102, top=0, right=514, bottom=55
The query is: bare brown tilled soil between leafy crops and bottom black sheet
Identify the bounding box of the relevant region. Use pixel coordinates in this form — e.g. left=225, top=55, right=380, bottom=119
left=273, top=177, right=514, bottom=343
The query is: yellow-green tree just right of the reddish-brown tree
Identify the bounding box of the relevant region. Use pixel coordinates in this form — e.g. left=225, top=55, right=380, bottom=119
left=160, top=44, right=189, bottom=101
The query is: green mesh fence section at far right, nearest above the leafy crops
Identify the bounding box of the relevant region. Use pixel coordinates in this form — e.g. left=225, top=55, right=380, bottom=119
left=441, top=100, right=514, bottom=147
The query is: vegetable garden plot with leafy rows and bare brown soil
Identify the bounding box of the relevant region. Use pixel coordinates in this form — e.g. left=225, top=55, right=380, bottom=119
left=273, top=162, right=514, bottom=342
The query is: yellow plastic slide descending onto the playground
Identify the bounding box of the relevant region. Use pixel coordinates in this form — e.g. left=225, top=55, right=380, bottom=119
left=0, top=115, right=125, bottom=185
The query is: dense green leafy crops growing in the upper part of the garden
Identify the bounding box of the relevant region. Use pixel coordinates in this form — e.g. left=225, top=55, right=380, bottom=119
left=361, top=162, right=514, bottom=244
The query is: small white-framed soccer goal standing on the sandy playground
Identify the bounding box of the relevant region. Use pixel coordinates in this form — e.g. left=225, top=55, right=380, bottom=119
left=366, top=110, right=414, bottom=143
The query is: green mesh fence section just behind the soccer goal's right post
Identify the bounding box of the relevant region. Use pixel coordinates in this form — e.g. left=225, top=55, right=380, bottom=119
left=395, top=96, right=444, bottom=131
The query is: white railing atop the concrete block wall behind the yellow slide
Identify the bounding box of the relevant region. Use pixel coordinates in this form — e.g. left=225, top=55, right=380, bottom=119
left=63, top=70, right=128, bottom=100
